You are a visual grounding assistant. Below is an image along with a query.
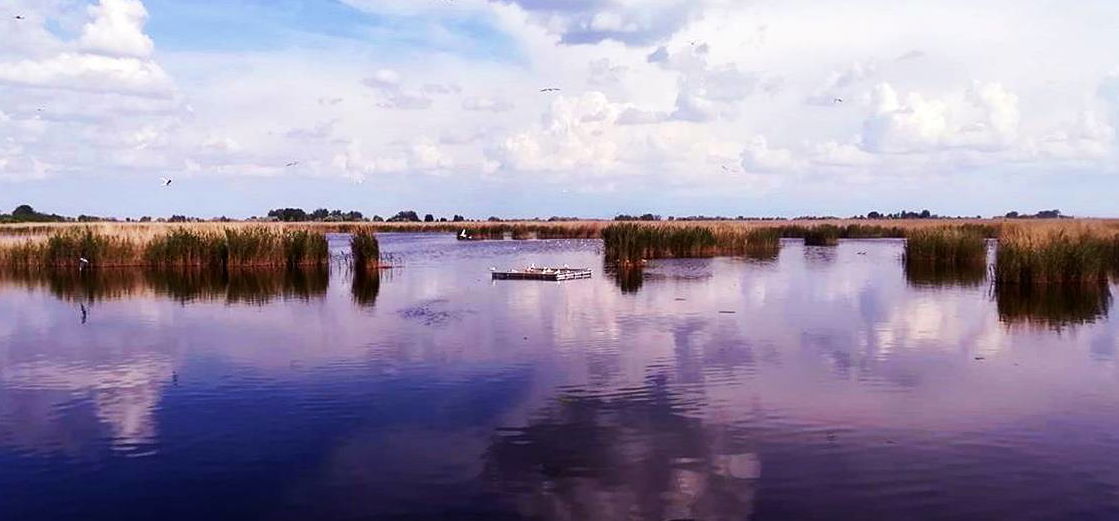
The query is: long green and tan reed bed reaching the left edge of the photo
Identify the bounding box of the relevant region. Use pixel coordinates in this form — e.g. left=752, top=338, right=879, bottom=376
left=0, top=227, right=330, bottom=268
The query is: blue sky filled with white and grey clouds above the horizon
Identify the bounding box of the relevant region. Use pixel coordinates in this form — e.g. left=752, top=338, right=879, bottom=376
left=0, top=0, right=1119, bottom=218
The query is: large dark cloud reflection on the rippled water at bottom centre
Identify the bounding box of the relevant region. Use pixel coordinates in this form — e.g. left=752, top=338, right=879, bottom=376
left=485, top=375, right=763, bottom=521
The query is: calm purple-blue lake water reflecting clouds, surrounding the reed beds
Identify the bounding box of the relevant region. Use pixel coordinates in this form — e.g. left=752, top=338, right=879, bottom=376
left=0, top=235, right=1119, bottom=521
